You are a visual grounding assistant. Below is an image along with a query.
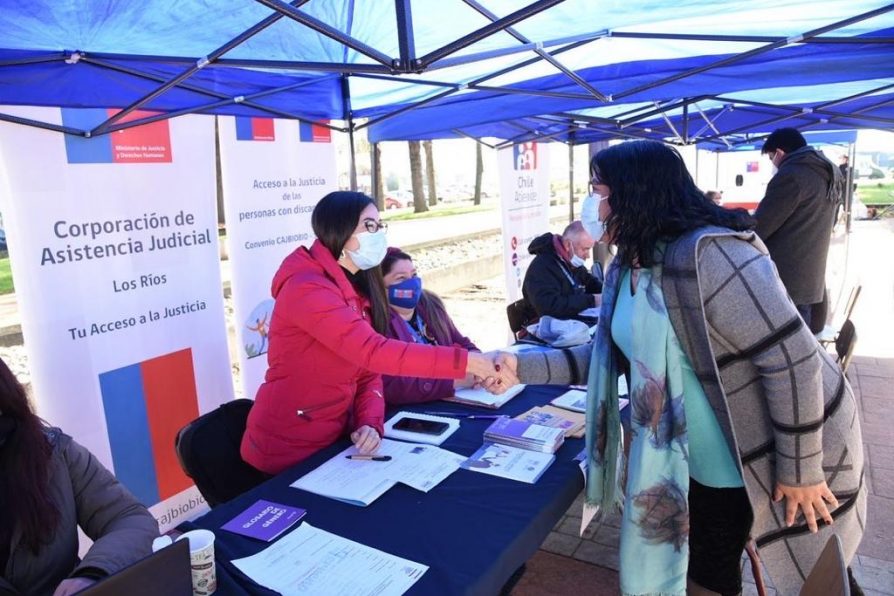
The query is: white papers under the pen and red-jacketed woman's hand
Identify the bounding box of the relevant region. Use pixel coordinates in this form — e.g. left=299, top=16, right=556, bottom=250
left=291, top=439, right=465, bottom=506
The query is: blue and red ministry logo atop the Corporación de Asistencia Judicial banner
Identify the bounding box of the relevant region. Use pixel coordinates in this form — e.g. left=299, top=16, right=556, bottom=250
left=62, top=108, right=173, bottom=164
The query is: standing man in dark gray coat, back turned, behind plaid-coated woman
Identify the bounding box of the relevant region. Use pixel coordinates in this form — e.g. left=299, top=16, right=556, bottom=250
left=754, top=128, right=841, bottom=332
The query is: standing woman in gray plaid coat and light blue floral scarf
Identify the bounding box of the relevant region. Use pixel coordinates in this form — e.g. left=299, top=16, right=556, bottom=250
left=503, top=141, right=866, bottom=594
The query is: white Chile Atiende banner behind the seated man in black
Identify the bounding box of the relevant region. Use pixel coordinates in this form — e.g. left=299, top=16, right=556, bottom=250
left=497, top=143, right=549, bottom=303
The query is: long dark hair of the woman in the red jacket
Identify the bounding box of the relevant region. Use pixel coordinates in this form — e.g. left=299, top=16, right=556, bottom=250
left=310, top=191, right=388, bottom=335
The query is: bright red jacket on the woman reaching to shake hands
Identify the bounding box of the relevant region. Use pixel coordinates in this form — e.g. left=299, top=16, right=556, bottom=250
left=241, top=241, right=468, bottom=474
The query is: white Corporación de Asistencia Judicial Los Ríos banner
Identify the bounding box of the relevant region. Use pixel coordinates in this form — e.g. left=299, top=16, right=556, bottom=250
left=0, top=107, right=233, bottom=531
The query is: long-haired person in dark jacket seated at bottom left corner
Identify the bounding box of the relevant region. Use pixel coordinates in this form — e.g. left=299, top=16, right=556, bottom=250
left=0, top=360, right=158, bottom=596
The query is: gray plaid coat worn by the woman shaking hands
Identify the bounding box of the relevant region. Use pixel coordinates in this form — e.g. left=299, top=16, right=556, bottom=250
left=518, top=228, right=866, bottom=594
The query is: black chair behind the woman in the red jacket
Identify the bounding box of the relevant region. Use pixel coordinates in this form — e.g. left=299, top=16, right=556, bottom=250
left=174, top=399, right=269, bottom=507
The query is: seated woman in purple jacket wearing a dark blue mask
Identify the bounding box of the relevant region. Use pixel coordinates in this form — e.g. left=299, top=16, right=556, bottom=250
left=382, top=247, right=480, bottom=405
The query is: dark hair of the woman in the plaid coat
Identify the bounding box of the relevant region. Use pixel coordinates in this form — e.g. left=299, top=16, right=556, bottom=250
left=590, top=141, right=755, bottom=267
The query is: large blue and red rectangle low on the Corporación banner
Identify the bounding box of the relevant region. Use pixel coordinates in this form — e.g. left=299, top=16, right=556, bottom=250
left=99, top=348, right=199, bottom=505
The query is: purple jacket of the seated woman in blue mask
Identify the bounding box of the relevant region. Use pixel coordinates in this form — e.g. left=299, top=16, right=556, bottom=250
left=382, top=305, right=481, bottom=406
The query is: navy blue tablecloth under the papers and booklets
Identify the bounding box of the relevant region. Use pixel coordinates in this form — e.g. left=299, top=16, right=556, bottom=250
left=181, top=386, right=584, bottom=595
